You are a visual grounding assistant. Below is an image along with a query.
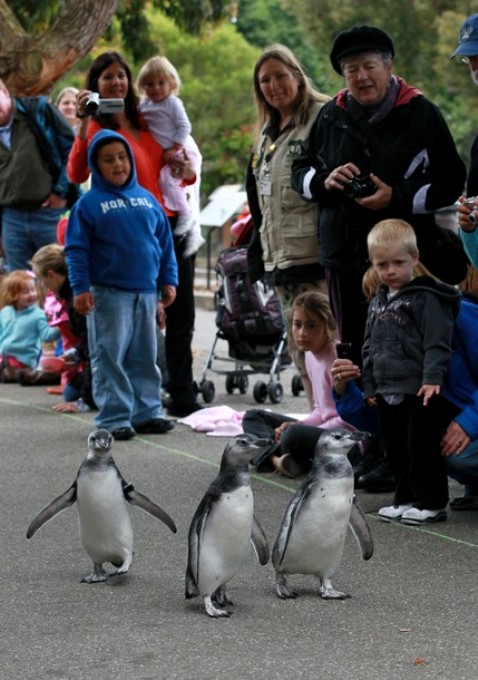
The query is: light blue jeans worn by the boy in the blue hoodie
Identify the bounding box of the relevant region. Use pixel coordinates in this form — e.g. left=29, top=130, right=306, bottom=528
left=87, top=286, right=163, bottom=430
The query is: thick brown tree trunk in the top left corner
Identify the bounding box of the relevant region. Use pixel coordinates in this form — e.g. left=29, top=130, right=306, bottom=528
left=0, top=0, right=118, bottom=96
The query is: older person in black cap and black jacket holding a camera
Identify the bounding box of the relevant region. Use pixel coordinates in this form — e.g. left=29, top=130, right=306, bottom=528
left=292, top=25, right=466, bottom=350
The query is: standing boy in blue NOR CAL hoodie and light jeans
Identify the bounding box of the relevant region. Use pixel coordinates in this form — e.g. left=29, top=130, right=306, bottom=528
left=65, top=130, right=178, bottom=440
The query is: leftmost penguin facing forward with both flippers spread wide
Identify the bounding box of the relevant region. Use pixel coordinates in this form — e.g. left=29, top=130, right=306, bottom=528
left=27, top=430, right=177, bottom=583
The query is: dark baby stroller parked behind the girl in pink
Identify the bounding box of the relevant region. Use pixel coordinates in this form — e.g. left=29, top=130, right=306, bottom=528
left=193, top=245, right=291, bottom=404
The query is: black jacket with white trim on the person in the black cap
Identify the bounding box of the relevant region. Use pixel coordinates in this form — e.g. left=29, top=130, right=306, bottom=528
left=292, top=81, right=466, bottom=277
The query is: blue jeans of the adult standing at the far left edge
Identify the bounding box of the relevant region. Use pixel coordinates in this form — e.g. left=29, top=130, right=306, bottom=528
left=2, top=207, right=66, bottom=271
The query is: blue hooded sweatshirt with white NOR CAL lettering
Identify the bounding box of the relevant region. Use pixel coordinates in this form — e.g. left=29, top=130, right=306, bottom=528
left=65, top=130, right=178, bottom=296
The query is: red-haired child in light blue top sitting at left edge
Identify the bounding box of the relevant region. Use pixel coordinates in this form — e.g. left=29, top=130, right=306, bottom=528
left=0, top=270, right=60, bottom=385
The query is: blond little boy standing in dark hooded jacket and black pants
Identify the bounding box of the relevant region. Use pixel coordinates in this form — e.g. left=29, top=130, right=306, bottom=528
left=362, top=219, right=460, bottom=524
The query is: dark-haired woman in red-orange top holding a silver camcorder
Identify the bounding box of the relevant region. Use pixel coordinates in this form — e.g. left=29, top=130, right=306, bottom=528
left=68, top=52, right=201, bottom=417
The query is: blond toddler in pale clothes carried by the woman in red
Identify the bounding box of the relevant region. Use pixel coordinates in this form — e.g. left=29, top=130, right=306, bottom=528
left=137, top=57, right=205, bottom=257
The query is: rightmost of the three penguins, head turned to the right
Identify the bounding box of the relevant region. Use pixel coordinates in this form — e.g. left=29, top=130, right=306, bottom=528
left=272, top=429, right=373, bottom=599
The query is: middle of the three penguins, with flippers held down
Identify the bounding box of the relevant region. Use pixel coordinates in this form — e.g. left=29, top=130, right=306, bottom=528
left=185, top=435, right=271, bottom=617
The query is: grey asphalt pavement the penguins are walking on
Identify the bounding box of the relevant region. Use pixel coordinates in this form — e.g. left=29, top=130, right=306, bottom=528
left=0, top=309, right=478, bottom=680
